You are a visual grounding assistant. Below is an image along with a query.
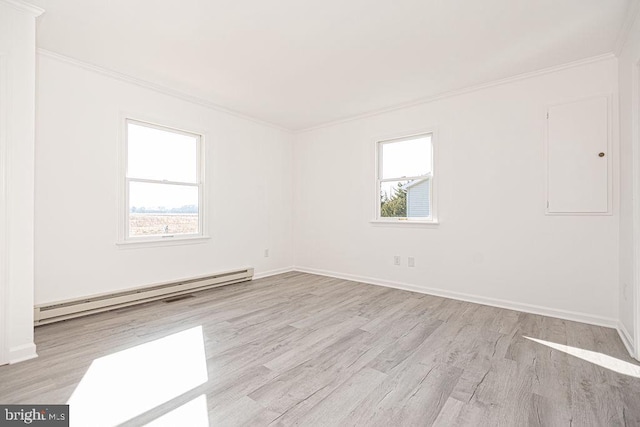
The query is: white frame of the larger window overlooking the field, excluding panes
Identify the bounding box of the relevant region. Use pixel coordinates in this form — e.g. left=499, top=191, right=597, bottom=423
left=117, top=115, right=209, bottom=247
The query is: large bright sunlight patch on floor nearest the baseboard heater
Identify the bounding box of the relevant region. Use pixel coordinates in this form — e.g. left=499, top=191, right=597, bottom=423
left=67, top=326, right=208, bottom=427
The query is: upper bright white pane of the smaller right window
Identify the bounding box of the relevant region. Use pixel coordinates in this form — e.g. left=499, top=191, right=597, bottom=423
left=380, top=135, right=431, bottom=179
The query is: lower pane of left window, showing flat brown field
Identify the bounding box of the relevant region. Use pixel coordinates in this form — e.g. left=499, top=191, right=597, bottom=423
left=129, top=182, right=199, bottom=236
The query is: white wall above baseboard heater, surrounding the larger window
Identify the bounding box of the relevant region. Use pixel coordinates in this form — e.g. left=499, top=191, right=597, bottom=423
left=35, top=54, right=293, bottom=304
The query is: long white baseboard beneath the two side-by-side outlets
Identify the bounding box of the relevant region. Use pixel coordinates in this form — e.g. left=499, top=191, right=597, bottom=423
left=293, top=266, right=618, bottom=329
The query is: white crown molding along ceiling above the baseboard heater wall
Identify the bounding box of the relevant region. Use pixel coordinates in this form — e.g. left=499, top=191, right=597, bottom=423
left=37, top=47, right=292, bottom=133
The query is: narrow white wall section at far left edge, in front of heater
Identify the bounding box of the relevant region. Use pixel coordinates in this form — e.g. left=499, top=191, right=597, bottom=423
left=0, top=0, right=41, bottom=365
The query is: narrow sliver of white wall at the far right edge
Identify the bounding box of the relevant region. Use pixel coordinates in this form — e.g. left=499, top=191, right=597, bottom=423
left=618, top=8, right=640, bottom=358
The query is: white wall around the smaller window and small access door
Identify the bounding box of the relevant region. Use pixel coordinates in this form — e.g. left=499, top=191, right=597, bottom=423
left=294, top=57, right=619, bottom=326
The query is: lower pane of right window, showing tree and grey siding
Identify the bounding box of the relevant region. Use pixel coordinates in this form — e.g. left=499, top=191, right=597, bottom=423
left=380, top=179, right=431, bottom=218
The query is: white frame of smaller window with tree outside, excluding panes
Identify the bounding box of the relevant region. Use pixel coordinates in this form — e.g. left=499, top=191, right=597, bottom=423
left=370, top=129, right=439, bottom=227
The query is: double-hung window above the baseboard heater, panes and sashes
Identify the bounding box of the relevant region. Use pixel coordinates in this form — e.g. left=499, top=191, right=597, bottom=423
left=124, top=119, right=203, bottom=241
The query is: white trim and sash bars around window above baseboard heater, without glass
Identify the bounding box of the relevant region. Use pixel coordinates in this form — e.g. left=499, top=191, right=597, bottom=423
left=116, top=113, right=210, bottom=248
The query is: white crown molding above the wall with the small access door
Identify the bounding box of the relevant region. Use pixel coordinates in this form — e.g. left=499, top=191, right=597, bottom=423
left=294, top=52, right=616, bottom=133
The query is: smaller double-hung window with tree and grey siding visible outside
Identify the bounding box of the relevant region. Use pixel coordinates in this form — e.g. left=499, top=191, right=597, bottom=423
left=376, top=133, right=435, bottom=222
